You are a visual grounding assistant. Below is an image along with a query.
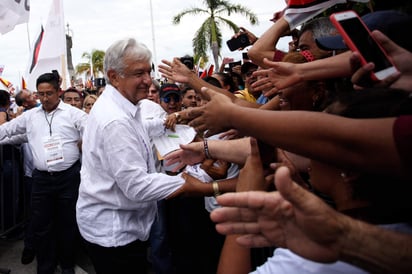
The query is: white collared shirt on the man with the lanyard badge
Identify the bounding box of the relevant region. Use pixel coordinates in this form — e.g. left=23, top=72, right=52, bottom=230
left=0, top=101, right=87, bottom=172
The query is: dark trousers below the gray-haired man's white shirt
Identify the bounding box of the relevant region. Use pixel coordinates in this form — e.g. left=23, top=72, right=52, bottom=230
left=85, top=237, right=148, bottom=274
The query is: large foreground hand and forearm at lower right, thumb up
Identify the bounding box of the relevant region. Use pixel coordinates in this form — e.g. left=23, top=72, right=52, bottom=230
left=211, top=167, right=412, bottom=273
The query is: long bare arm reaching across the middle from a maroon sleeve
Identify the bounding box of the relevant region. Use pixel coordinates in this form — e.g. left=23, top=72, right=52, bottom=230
left=189, top=86, right=404, bottom=179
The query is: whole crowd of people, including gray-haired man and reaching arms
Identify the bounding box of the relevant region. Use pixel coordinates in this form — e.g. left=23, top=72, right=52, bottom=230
left=0, top=1, right=412, bottom=274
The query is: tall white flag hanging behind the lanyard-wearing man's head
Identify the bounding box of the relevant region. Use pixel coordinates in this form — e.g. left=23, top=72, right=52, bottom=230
left=26, top=0, right=68, bottom=90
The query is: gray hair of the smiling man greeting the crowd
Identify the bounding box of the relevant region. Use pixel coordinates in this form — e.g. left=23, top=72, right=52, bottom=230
left=103, top=38, right=152, bottom=84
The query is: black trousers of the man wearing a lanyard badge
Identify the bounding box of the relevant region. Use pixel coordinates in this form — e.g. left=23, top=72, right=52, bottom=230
left=31, top=161, right=80, bottom=274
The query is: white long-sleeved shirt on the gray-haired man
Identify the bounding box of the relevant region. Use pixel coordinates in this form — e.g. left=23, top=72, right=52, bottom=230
left=76, top=85, right=184, bottom=247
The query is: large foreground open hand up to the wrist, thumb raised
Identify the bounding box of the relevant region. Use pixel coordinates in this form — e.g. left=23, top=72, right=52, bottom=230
left=211, top=167, right=348, bottom=262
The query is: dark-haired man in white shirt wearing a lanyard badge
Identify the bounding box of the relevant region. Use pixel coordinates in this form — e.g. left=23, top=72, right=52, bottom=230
left=0, top=73, right=87, bottom=274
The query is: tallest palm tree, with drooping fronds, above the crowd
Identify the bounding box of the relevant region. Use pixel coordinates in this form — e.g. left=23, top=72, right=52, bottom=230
left=173, top=0, right=258, bottom=69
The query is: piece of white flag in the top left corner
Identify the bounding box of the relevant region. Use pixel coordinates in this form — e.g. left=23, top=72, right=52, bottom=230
left=0, top=0, right=30, bottom=34
